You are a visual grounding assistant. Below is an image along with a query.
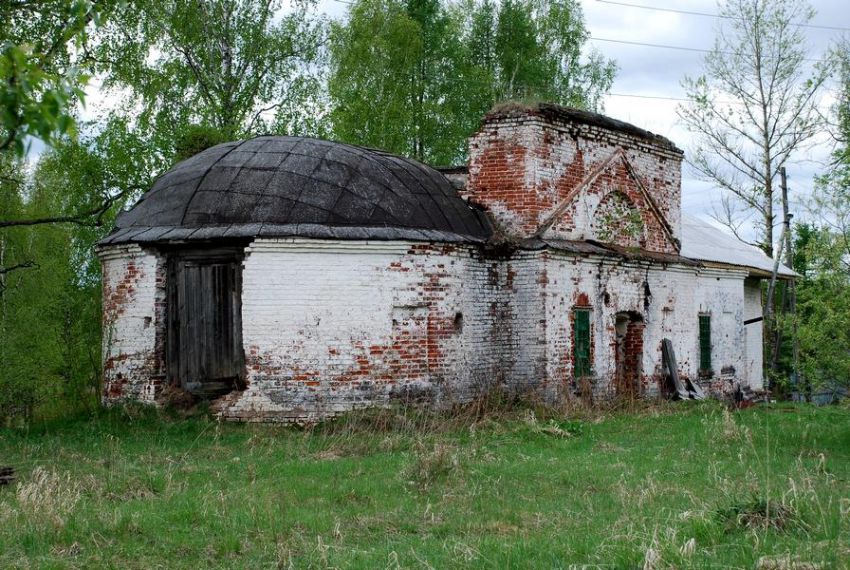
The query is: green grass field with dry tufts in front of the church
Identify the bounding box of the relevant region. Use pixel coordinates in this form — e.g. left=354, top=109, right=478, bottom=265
left=0, top=398, right=850, bottom=569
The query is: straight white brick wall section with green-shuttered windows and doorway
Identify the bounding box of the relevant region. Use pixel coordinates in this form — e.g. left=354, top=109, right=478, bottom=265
left=544, top=252, right=744, bottom=398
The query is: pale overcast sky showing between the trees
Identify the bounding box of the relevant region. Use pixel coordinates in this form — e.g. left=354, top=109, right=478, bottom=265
left=76, top=0, right=850, bottom=229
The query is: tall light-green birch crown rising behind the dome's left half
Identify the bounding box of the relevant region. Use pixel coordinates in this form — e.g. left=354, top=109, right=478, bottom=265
left=97, top=0, right=324, bottom=153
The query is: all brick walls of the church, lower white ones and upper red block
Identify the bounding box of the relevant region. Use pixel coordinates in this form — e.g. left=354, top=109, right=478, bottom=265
left=100, top=106, right=762, bottom=422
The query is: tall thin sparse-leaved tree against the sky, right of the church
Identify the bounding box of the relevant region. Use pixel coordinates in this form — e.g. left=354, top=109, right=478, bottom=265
left=678, top=0, right=829, bottom=255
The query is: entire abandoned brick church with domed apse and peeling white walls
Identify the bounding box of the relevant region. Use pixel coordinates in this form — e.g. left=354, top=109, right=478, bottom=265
left=99, top=104, right=792, bottom=421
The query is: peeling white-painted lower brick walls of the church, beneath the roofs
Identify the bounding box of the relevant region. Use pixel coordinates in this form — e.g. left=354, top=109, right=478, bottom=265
left=102, top=235, right=760, bottom=421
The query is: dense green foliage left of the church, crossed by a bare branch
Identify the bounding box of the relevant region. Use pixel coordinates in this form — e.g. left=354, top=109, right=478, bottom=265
left=0, top=120, right=155, bottom=423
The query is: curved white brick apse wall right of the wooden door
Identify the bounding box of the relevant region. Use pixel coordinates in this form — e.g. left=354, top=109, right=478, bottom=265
left=219, top=239, right=539, bottom=421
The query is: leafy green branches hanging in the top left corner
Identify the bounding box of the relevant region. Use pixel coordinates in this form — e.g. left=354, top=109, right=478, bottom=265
left=0, top=0, right=105, bottom=155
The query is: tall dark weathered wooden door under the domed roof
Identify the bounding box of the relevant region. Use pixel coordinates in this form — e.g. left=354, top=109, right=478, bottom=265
left=167, top=250, right=245, bottom=397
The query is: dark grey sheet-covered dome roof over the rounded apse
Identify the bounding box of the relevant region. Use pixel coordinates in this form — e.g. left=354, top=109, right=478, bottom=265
left=100, top=136, right=491, bottom=245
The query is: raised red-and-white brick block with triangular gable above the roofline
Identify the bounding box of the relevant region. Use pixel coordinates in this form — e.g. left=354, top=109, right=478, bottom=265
left=465, top=107, right=682, bottom=253
